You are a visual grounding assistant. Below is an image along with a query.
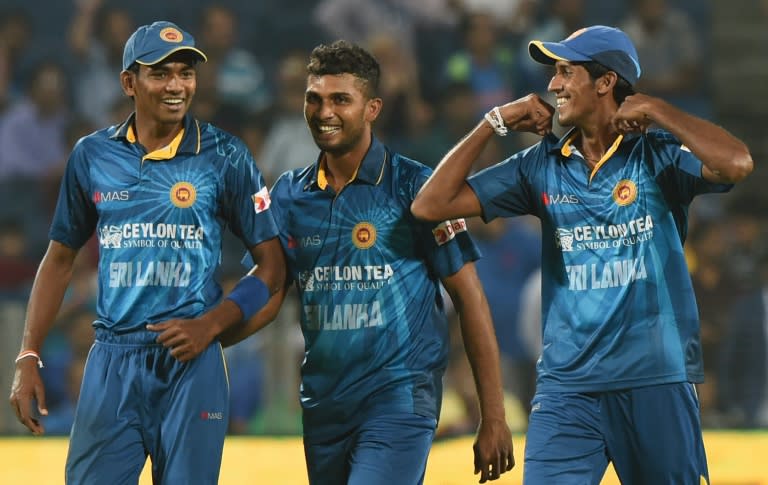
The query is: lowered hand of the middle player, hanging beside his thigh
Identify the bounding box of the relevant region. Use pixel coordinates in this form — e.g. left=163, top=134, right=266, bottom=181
left=472, top=420, right=515, bottom=483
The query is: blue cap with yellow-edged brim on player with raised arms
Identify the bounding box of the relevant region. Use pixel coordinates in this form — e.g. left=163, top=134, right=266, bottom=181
left=528, top=25, right=641, bottom=85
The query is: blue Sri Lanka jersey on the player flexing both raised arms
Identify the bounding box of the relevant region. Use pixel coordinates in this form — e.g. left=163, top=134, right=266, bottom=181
left=468, top=131, right=731, bottom=392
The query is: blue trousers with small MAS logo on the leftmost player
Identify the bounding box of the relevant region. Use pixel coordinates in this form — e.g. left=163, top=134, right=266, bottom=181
left=66, top=330, right=229, bottom=485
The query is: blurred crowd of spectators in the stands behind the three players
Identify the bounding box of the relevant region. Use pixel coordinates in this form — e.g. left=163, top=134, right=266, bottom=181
left=0, top=0, right=768, bottom=435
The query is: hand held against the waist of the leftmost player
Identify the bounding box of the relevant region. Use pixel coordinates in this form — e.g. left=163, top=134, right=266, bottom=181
left=147, top=318, right=215, bottom=362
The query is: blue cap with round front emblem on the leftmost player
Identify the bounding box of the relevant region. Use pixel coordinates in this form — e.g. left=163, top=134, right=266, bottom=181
left=123, top=21, right=208, bottom=70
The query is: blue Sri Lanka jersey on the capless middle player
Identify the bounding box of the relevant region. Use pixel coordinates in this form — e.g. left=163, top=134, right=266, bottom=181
left=271, top=138, right=478, bottom=439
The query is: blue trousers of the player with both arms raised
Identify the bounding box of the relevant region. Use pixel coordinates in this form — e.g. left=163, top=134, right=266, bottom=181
left=523, top=383, right=709, bottom=485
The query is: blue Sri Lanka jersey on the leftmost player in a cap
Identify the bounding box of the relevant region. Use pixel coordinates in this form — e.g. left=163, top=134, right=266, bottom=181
left=50, top=116, right=277, bottom=333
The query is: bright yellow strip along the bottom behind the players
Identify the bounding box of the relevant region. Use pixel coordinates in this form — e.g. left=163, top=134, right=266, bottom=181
left=0, top=432, right=768, bottom=485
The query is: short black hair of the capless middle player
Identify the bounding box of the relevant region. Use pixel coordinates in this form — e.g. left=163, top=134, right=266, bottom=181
left=307, top=40, right=381, bottom=98
